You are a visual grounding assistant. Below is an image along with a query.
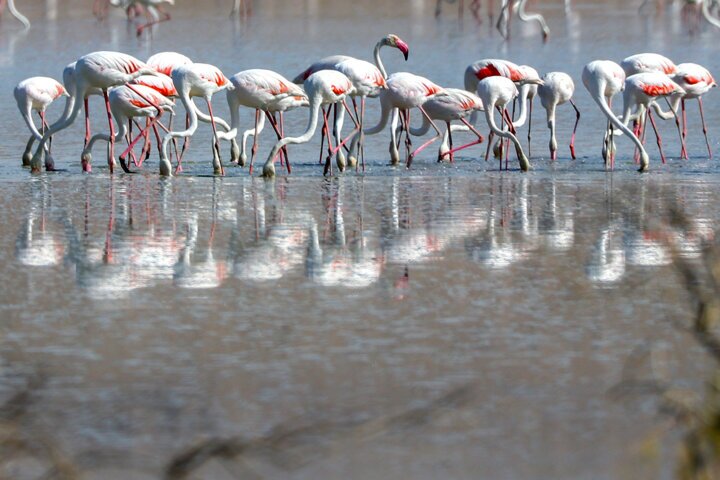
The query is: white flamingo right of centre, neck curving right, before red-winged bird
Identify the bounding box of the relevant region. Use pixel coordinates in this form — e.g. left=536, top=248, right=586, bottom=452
left=477, top=76, right=542, bottom=172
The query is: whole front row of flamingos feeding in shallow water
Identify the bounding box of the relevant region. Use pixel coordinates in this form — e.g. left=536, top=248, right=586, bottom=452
left=14, top=34, right=716, bottom=177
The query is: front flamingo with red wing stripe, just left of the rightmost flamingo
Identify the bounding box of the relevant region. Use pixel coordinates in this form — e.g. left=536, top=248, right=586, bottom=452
left=623, top=72, right=685, bottom=170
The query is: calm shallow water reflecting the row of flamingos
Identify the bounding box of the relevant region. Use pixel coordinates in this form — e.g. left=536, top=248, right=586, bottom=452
left=0, top=1, right=720, bottom=479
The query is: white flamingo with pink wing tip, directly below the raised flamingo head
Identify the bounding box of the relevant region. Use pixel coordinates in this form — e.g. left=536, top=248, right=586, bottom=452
left=365, top=72, right=443, bottom=167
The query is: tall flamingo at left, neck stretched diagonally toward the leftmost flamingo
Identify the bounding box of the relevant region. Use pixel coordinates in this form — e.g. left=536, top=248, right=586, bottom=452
left=31, top=52, right=155, bottom=172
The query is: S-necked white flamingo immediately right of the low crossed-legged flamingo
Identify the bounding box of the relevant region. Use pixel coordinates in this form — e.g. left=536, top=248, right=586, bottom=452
left=160, top=63, right=234, bottom=176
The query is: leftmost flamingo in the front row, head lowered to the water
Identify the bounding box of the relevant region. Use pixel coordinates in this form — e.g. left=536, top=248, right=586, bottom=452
left=13, top=77, right=71, bottom=167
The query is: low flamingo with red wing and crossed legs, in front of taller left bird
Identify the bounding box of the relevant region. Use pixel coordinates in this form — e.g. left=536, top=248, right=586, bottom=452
left=81, top=85, right=174, bottom=171
